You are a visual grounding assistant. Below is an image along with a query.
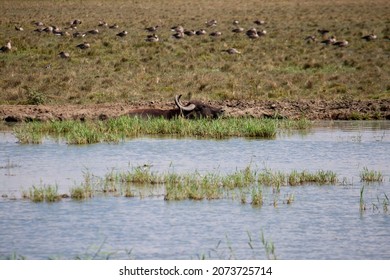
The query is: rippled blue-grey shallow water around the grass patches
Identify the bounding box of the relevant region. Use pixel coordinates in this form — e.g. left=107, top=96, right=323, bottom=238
left=0, top=122, right=390, bottom=259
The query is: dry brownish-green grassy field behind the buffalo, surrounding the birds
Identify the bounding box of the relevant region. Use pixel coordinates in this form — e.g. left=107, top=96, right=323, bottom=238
left=0, top=0, right=390, bottom=104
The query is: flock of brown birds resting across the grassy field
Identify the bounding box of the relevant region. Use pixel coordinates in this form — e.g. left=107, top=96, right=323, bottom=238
left=0, top=19, right=377, bottom=59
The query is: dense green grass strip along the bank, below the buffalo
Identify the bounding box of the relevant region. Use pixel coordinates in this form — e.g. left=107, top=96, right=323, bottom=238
left=14, top=116, right=311, bottom=144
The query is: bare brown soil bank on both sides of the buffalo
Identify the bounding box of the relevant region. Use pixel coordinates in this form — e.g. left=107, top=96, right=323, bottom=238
left=0, top=99, right=390, bottom=122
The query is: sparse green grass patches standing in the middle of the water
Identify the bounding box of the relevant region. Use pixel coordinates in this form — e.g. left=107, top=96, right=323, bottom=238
left=23, top=166, right=337, bottom=203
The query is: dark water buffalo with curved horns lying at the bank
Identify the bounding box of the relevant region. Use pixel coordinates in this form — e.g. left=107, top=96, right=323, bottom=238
left=129, top=95, right=224, bottom=119
